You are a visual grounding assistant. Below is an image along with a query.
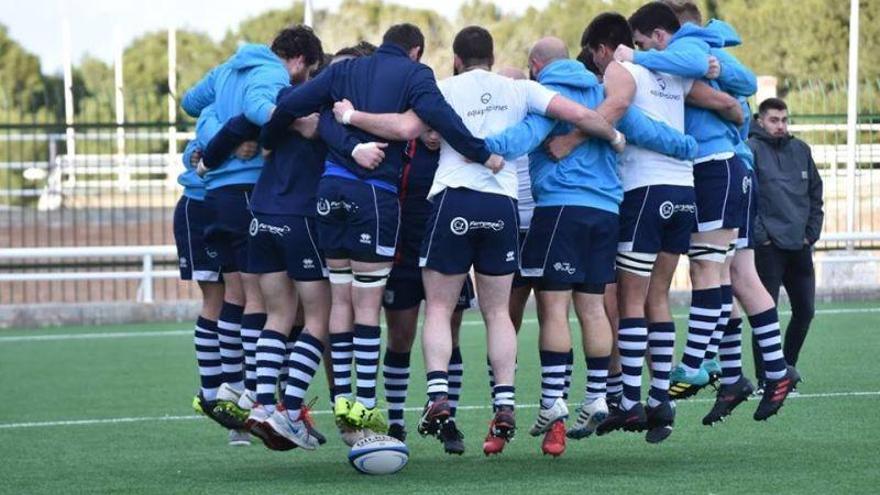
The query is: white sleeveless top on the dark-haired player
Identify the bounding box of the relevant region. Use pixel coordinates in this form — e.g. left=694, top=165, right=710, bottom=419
left=618, top=62, right=694, bottom=191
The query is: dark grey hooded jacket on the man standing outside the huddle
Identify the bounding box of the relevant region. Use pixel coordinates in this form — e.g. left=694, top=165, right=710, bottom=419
left=749, top=122, right=825, bottom=250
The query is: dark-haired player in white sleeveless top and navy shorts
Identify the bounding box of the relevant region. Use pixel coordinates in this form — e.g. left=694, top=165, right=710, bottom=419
left=552, top=13, right=742, bottom=442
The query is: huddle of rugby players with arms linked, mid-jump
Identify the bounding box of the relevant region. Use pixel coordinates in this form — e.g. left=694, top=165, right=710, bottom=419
left=175, top=0, right=799, bottom=456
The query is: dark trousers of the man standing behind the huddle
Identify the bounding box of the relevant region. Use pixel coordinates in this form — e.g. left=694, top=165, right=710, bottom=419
left=752, top=244, right=816, bottom=380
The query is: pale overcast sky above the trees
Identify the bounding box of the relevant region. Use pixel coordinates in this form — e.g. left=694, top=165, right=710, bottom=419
left=0, top=0, right=548, bottom=73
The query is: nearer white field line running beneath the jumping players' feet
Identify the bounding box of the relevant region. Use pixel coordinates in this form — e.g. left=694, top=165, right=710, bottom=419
left=0, top=391, right=880, bottom=430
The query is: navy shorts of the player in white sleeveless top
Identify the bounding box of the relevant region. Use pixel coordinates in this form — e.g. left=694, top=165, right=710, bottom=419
left=617, top=185, right=697, bottom=254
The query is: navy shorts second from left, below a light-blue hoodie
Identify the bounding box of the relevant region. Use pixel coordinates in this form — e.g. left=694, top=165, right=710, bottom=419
left=205, top=185, right=254, bottom=273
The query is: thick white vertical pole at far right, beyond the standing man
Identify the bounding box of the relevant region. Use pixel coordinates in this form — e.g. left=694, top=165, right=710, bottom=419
left=846, top=0, right=859, bottom=251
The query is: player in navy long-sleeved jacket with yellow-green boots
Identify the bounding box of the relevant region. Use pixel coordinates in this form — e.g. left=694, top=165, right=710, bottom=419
left=262, top=24, right=501, bottom=438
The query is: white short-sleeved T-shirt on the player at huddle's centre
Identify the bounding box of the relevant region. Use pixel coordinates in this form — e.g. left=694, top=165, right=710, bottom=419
left=428, top=69, right=557, bottom=199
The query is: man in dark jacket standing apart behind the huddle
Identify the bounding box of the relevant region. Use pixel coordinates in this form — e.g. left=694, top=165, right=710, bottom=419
left=749, top=98, right=824, bottom=392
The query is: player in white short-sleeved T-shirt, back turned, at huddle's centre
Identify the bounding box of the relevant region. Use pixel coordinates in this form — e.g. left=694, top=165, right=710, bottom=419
left=334, top=26, right=625, bottom=455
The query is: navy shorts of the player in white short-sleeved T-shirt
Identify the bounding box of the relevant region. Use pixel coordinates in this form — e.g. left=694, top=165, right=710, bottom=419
left=419, top=188, right=519, bottom=275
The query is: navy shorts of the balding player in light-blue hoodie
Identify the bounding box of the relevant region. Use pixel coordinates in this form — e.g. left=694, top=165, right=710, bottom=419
left=521, top=206, right=620, bottom=294
